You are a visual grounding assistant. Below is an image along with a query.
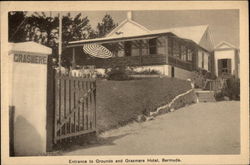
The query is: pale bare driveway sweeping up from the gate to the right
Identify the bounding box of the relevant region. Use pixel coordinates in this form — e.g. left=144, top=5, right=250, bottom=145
left=64, top=101, right=240, bottom=155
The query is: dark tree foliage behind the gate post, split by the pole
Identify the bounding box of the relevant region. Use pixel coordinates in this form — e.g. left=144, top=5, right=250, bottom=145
left=9, top=12, right=94, bottom=49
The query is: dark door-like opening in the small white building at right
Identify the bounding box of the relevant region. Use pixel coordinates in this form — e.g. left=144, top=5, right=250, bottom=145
left=218, top=59, right=232, bottom=76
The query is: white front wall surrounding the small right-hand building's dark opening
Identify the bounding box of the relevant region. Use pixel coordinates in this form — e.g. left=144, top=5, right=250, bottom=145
left=214, top=49, right=235, bottom=76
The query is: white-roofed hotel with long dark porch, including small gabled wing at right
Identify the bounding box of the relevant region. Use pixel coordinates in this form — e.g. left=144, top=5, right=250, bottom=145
left=65, top=12, right=239, bottom=79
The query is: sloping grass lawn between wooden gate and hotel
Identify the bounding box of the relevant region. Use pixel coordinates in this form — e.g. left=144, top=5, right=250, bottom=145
left=97, top=78, right=191, bottom=132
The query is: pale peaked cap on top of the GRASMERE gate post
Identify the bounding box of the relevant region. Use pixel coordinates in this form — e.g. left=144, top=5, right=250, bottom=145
left=9, top=41, right=52, bottom=55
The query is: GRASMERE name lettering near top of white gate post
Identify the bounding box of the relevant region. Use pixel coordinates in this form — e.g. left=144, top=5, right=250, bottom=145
left=14, top=54, right=47, bottom=64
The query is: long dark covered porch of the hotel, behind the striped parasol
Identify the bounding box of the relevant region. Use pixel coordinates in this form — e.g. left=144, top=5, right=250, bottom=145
left=66, top=34, right=198, bottom=71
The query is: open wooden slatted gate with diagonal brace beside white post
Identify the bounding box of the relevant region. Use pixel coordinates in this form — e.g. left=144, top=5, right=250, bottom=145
left=54, top=73, right=96, bottom=144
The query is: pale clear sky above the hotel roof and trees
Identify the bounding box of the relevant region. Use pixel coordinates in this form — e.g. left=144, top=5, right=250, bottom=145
left=32, top=10, right=239, bottom=47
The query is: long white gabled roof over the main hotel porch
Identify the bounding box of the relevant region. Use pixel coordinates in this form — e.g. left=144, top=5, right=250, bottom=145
left=69, top=19, right=213, bottom=50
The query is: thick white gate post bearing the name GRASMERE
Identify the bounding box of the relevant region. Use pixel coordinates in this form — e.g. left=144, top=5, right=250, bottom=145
left=9, top=42, right=52, bottom=156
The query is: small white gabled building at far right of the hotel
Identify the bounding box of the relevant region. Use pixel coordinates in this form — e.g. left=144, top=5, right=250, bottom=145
left=214, top=41, right=240, bottom=78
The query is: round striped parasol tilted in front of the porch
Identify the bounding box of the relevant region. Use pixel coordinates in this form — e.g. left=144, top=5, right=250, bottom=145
left=83, top=44, right=112, bottom=58
